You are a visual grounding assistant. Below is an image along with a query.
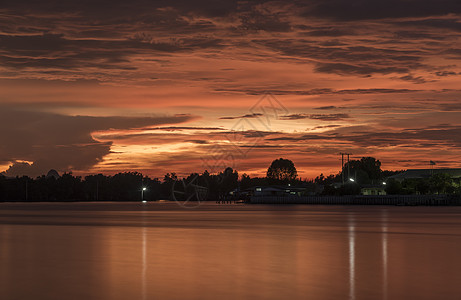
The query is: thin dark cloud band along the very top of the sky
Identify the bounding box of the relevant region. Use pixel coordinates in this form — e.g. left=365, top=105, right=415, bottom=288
left=2, top=0, right=461, bottom=21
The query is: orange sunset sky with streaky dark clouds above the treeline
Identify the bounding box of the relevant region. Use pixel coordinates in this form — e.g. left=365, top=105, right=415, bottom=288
left=0, top=0, right=461, bottom=178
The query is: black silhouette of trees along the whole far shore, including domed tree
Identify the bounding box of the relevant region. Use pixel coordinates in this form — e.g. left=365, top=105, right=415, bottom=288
left=0, top=157, right=461, bottom=202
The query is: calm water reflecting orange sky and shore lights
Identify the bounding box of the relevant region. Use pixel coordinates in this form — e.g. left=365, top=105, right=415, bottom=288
left=0, top=203, right=461, bottom=300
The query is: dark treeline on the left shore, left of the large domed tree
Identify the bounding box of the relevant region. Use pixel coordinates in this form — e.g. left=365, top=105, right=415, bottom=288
left=0, top=168, right=309, bottom=201
